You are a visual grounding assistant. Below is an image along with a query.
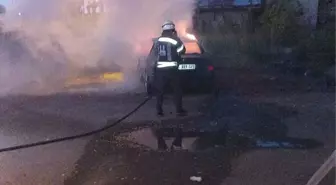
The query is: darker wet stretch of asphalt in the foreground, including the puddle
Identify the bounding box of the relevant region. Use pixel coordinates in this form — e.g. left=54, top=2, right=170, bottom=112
left=61, top=93, right=336, bottom=185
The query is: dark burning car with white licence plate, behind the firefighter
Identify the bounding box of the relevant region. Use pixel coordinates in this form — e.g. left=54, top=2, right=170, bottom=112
left=137, top=33, right=215, bottom=94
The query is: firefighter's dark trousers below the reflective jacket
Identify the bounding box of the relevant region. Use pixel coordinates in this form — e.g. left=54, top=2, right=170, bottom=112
left=155, top=70, right=182, bottom=112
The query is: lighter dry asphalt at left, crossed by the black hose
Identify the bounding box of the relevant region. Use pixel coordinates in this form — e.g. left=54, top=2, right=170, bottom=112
left=0, top=83, right=211, bottom=185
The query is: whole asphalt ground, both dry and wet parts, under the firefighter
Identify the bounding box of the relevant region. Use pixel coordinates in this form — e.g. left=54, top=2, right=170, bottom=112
left=0, top=73, right=336, bottom=185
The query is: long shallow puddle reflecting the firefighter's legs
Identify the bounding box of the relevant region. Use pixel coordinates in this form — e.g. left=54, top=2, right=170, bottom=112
left=117, top=128, right=322, bottom=152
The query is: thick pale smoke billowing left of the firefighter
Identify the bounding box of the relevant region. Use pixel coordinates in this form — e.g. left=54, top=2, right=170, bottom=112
left=0, top=0, right=194, bottom=94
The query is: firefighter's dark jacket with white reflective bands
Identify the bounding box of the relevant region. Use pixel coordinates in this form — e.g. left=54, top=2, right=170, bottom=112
left=154, top=35, right=186, bottom=69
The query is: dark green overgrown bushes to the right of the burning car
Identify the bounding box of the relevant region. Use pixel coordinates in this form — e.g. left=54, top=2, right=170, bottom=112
left=197, top=0, right=336, bottom=71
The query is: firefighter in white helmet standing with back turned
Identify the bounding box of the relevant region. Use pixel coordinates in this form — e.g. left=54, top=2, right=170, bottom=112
left=154, top=21, right=187, bottom=116
